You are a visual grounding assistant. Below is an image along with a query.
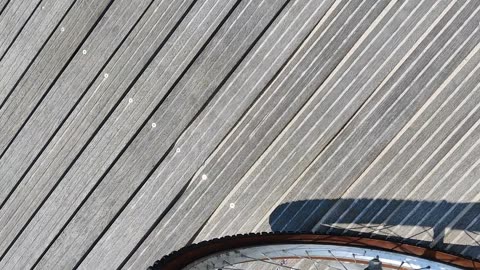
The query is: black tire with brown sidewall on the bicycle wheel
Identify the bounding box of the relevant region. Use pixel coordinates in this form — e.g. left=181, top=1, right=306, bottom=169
left=148, top=232, right=480, bottom=270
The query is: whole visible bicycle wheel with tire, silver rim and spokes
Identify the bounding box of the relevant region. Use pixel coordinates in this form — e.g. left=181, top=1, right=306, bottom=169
left=149, top=233, right=480, bottom=270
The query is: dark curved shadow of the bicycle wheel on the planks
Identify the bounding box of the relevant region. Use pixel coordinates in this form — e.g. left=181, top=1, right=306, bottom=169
left=269, top=199, right=480, bottom=259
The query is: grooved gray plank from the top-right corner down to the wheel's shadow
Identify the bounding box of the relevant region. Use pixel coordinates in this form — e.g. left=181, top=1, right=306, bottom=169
left=264, top=2, right=478, bottom=235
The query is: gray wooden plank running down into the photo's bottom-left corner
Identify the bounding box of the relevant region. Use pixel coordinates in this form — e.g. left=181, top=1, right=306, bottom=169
left=1, top=1, right=240, bottom=266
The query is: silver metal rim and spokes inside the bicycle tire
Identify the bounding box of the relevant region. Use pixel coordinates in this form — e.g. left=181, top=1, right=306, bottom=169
left=185, top=244, right=460, bottom=270
